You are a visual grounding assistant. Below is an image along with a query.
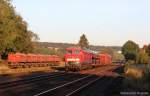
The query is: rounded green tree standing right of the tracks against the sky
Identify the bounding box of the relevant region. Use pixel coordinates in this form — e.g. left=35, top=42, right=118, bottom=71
left=122, top=40, right=139, bottom=62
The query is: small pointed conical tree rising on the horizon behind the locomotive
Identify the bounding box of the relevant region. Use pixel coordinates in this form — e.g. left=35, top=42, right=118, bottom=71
left=78, top=34, right=89, bottom=48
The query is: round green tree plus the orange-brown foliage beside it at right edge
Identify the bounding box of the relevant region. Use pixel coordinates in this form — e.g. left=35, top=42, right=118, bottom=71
left=122, top=40, right=150, bottom=64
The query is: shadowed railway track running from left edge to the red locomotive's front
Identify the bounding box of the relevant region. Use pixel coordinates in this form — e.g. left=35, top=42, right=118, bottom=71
left=0, top=72, right=65, bottom=91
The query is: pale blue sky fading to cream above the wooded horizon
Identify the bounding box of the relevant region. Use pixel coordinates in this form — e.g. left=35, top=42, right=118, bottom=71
left=12, top=0, right=150, bottom=46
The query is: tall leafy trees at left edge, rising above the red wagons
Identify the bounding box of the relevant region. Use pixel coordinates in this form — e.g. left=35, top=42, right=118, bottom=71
left=0, top=0, right=38, bottom=58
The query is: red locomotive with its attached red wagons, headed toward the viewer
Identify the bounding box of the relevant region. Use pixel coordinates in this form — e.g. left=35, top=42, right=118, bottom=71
left=65, top=48, right=112, bottom=70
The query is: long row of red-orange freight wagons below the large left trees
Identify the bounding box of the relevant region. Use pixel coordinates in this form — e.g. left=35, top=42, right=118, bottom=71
left=8, top=53, right=61, bottom=68
